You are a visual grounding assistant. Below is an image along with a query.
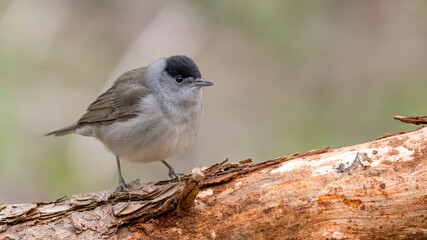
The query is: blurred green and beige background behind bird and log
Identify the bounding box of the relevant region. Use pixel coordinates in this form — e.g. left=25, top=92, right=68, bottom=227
left=0, top=0, right=427, bottom=203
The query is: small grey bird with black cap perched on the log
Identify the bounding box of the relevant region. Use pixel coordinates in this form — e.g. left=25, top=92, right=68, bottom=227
left=46, top=56, right=213, bottom=191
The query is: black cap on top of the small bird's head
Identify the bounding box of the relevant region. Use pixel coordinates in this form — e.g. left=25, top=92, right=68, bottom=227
left=165, top=55, right=202, bottom=79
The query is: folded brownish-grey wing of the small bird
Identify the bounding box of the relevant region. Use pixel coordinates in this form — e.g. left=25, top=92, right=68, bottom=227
left=77, top=68, right=149, bottom=125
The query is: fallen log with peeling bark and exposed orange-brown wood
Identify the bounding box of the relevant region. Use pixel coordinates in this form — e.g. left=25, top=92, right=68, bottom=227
left=0, top=122, right=427, bottom=240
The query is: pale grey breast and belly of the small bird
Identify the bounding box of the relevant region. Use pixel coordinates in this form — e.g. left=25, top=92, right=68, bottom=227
left=99, top=96, right=202, bottom=162
